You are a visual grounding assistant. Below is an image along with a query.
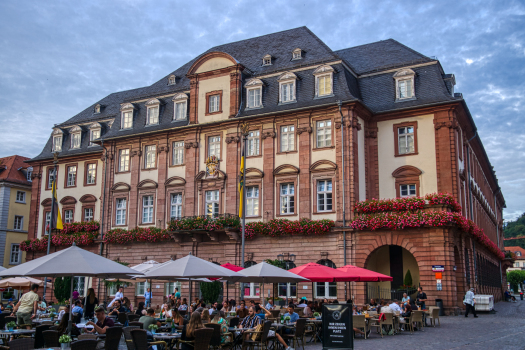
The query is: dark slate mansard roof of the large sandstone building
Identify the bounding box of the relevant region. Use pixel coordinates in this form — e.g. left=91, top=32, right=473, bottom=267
left=33, top=27, right=454, bottom=160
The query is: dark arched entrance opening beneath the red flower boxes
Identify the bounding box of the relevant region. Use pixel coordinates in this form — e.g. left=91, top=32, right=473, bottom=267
left=365, top=245, right=420, bottom=300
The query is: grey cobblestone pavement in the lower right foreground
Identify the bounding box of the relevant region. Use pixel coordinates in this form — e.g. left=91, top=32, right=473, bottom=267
left=296, top=299, right=525, bottom=350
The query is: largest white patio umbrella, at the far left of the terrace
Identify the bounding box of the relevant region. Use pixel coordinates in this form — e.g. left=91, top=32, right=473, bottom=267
left=0, top=243, right=141, bottom=332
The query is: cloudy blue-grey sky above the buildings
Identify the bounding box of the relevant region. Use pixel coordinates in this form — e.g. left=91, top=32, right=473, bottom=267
left=0, top=0, right=525, bottom=219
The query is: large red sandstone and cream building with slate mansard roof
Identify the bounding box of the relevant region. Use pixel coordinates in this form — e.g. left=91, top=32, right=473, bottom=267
left=27, top=27, right=505, bottom=312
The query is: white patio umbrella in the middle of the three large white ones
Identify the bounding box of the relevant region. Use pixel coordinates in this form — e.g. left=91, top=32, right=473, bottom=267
left=144, top=253, right=243, bottom=303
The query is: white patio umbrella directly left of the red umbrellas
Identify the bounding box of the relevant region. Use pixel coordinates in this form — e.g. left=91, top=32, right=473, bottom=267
left=238, top=261, right=310, bottom=304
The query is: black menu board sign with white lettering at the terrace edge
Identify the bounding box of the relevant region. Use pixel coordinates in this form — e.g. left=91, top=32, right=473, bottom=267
left=323, top=304, right=354, bottom=350
